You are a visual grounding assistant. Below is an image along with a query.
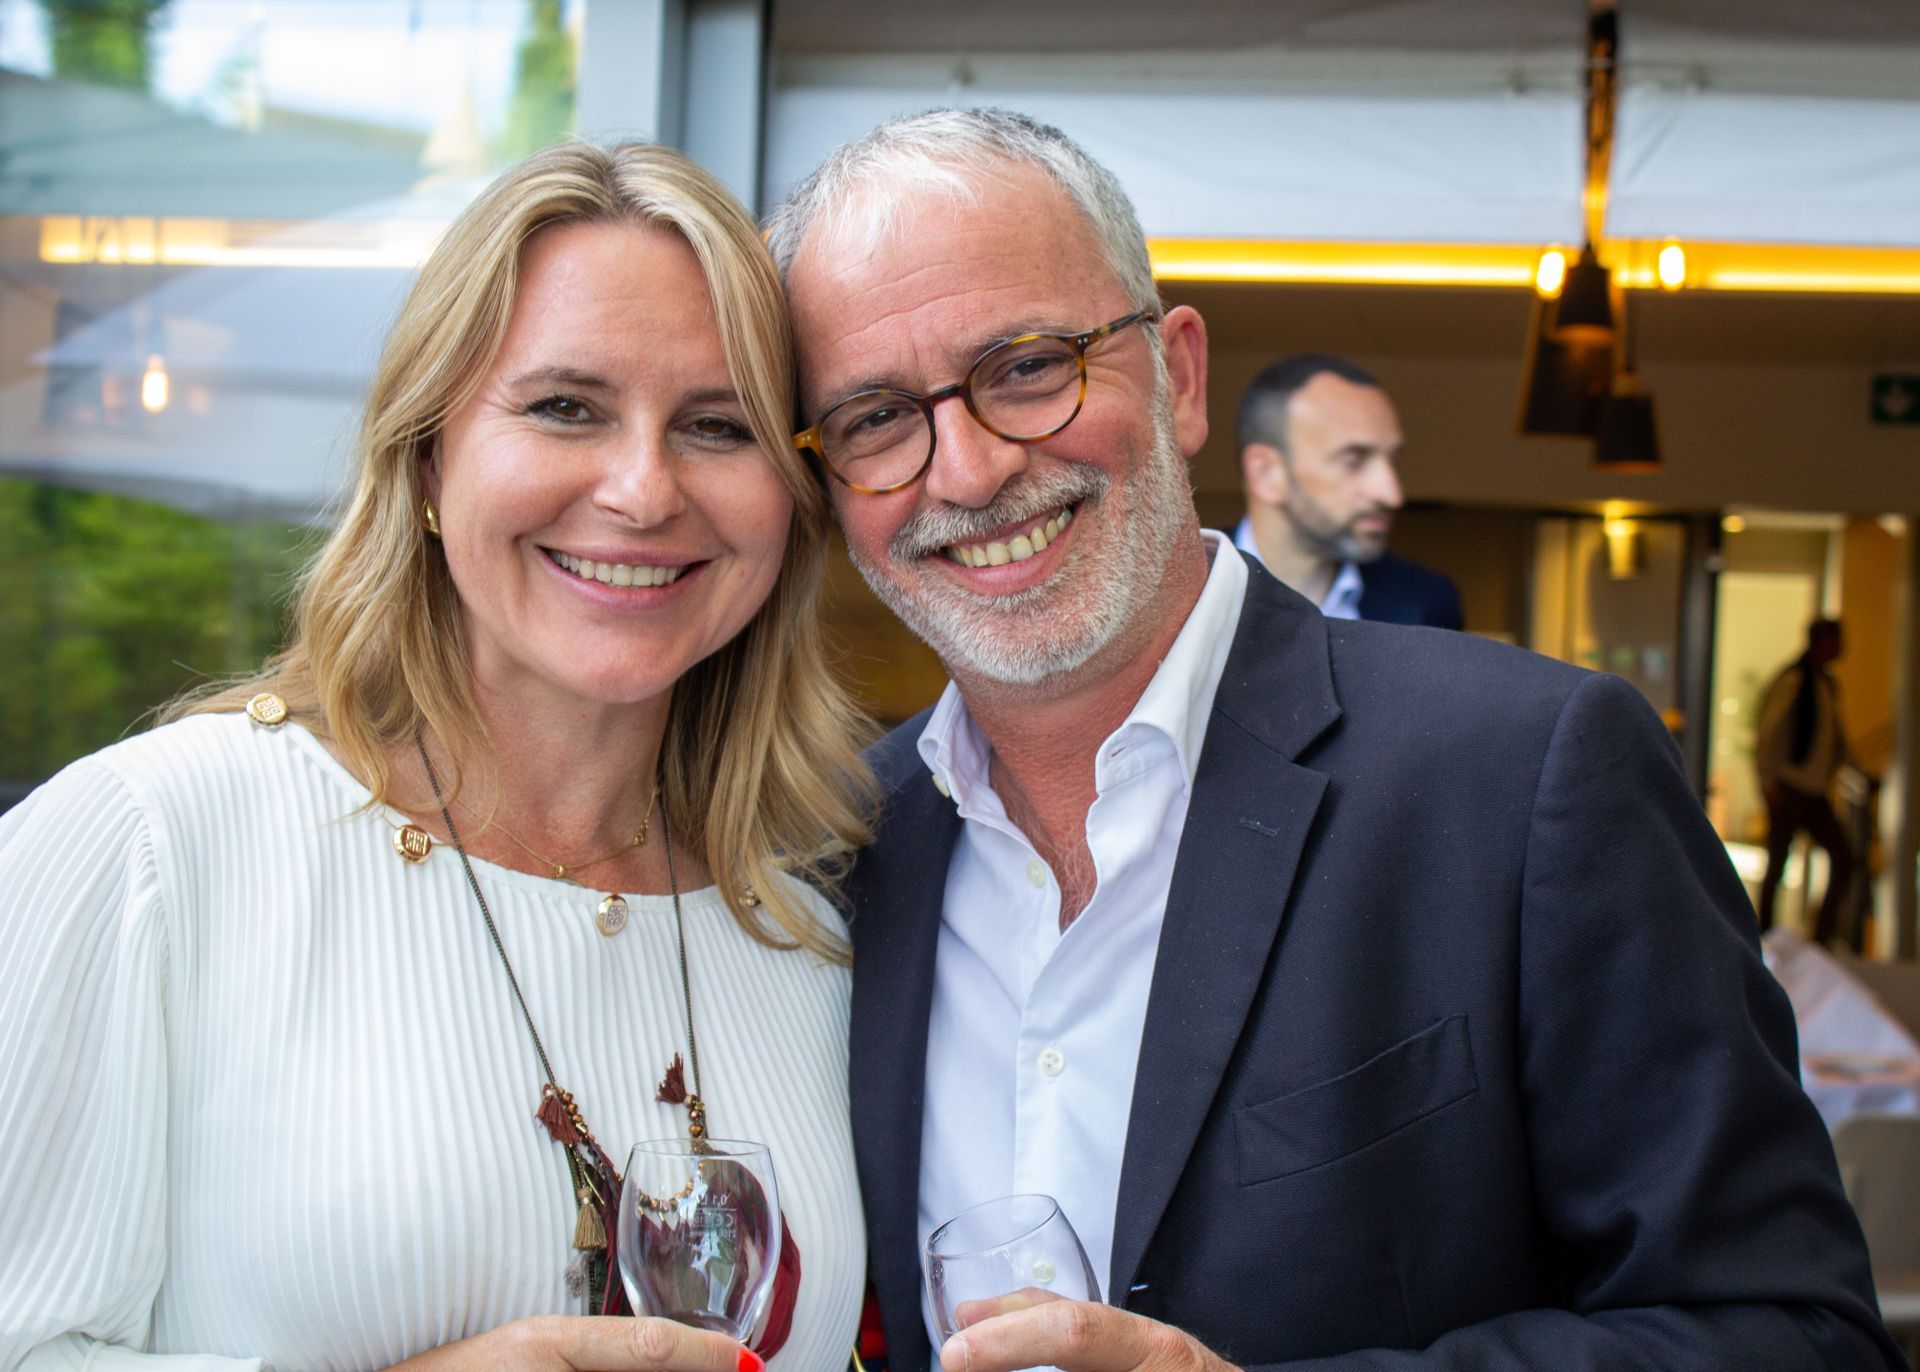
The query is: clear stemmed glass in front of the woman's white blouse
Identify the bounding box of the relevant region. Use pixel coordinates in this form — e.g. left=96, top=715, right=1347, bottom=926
left=614, top=1138, right=781, bottom=1343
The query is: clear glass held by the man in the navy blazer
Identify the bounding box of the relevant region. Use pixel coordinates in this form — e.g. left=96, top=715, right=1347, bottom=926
left=927, top=1195, right=1100, bottom=1343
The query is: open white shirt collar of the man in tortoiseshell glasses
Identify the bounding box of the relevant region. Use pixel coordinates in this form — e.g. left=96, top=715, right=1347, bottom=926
left=918, top=530, right=1246, bottom=812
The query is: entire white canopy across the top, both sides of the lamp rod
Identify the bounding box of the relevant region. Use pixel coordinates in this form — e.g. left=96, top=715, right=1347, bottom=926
left=762, top=0, right=1920, bottom=248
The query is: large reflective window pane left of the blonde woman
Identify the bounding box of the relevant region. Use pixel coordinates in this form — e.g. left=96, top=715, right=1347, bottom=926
left=0, top=0, right=584, bottom=804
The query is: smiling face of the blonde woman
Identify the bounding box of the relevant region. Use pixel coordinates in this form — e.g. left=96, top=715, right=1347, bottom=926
left=426, top=223, right=793, bottom=710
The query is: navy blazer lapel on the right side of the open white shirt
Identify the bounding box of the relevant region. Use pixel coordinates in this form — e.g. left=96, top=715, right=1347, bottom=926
left=1108, top=562, right=1340, bottom=1305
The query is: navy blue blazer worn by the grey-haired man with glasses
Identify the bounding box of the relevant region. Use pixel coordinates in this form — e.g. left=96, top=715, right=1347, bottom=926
left=851, top=564, right=1905, bottom=1372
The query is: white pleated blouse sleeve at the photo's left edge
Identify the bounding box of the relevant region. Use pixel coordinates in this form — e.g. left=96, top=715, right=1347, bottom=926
left=0, top=758, right=263, bottom=1372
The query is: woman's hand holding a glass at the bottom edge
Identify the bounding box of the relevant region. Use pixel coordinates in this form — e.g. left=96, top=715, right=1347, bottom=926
left=394, top=1314, right=766, bottom=1372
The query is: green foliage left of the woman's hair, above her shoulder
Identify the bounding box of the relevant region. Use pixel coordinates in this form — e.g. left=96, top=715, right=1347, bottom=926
left=0, top=480, right=315, bottom=781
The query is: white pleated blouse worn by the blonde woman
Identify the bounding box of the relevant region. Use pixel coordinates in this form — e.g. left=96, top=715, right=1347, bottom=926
left=0, top=714, right=866, bottom=1372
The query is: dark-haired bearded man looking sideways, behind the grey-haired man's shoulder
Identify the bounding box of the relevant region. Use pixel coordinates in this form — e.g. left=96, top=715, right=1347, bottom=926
left=1233, top=353, right=1463, bottom=629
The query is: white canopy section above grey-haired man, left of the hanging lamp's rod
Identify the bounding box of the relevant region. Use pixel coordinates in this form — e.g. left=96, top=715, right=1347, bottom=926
left=762, top=0, right=1586, bottom=244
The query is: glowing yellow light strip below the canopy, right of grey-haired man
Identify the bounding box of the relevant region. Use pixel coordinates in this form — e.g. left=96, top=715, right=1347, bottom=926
left=1148, top=238, right=1920, bottom=296
